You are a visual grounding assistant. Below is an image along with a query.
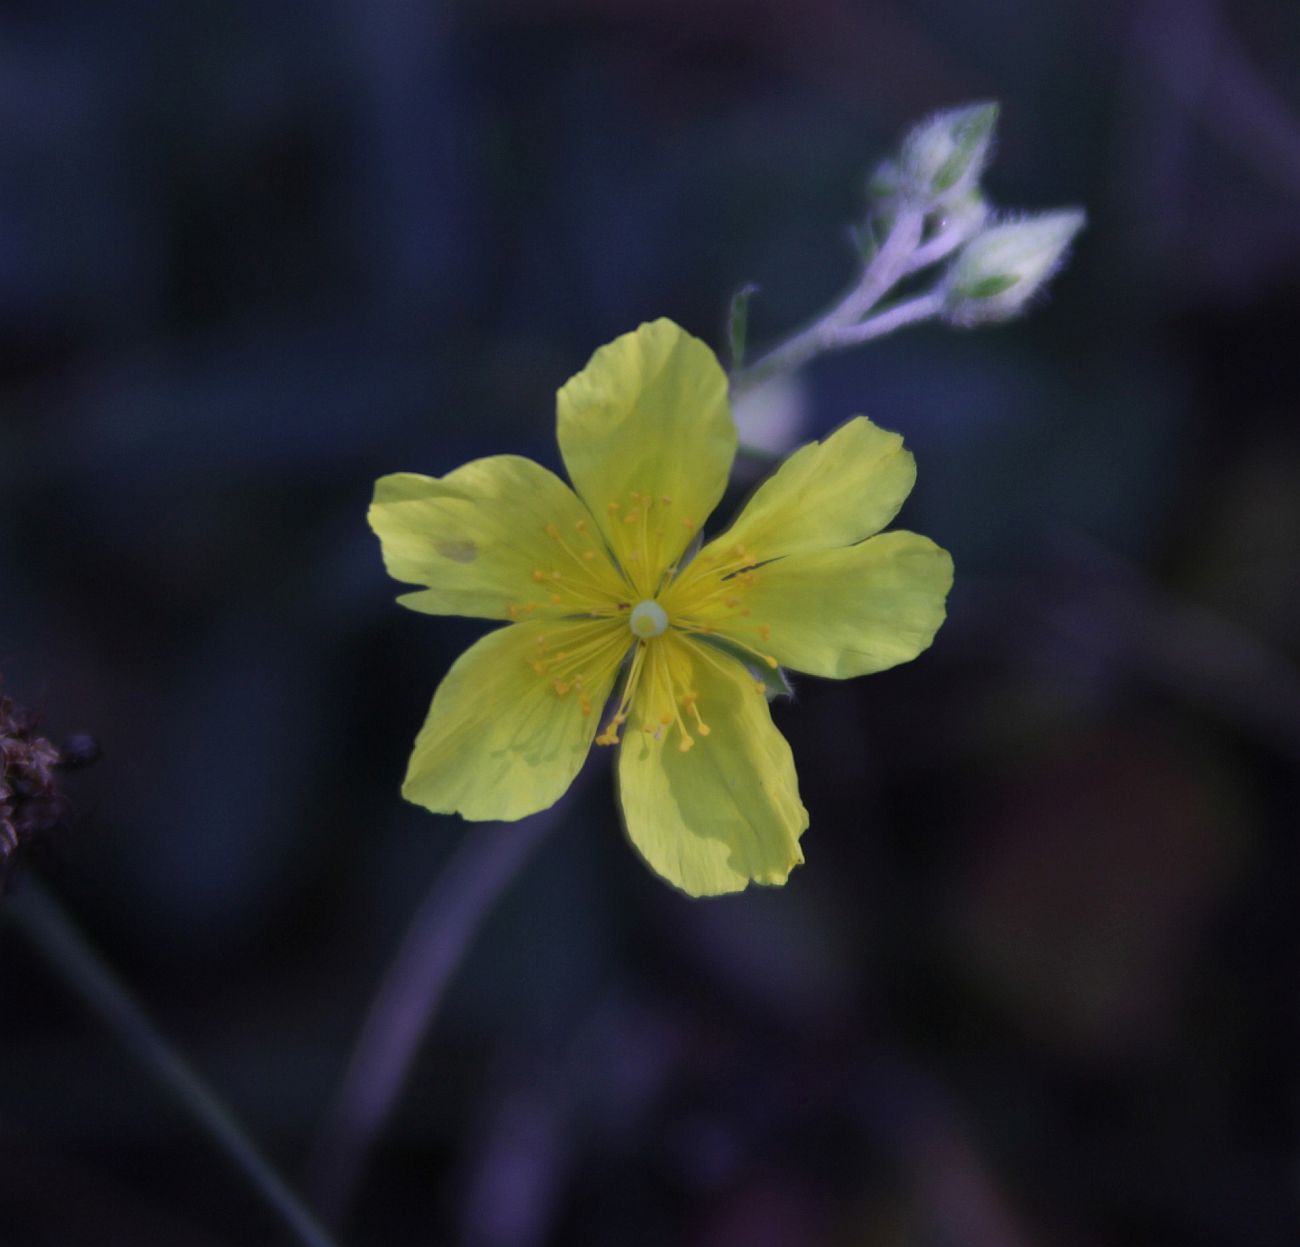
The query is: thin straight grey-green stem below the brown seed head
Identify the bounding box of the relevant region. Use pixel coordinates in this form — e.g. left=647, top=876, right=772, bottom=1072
left=4, top=876, right=335, bottom=1247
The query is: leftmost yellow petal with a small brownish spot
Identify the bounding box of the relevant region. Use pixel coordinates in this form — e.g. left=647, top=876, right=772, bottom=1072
left=369, top=455, right=621, bottom=619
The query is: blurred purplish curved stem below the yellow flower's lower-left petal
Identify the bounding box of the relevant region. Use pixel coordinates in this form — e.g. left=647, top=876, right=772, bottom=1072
left=308, top=800, right=581, bottom=1224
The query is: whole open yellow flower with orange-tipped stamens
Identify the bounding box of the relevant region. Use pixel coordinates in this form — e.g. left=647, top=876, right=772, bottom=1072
left=369, top=320, right=952, bottom=896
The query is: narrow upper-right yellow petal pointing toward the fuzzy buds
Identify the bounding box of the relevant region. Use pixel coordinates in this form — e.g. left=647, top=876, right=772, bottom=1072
left=716, top=416, right=917, bottom=563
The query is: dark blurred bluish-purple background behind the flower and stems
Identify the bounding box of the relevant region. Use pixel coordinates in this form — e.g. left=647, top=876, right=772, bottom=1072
left=0, top=0, right=1300, bottom=1247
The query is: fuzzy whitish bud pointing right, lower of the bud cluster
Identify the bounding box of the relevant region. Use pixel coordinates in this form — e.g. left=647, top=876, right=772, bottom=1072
left=944, top=208, right=1084, bottom=326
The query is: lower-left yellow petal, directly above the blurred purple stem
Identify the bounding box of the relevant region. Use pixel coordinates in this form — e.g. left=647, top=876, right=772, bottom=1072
left=402, top=619, right=627, bottom=820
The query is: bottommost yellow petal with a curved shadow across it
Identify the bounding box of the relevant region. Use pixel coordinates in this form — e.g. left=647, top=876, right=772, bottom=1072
left=619, top=635, right=809, bottom=896
